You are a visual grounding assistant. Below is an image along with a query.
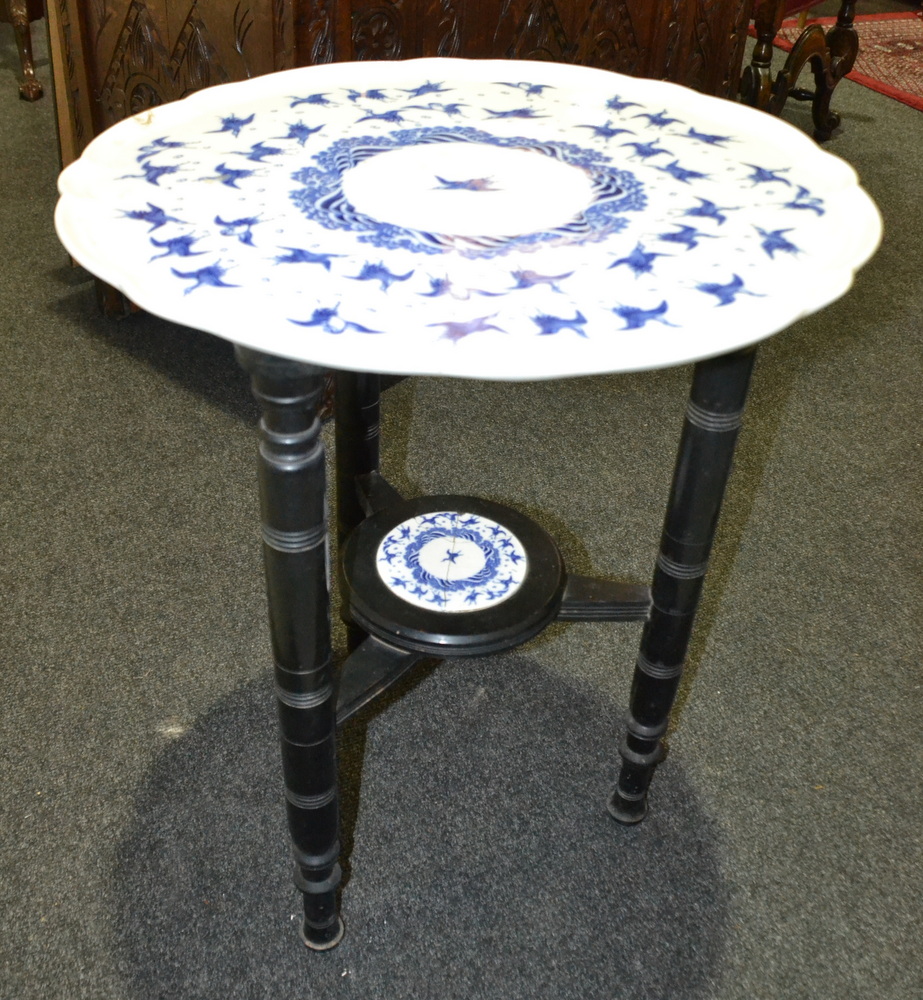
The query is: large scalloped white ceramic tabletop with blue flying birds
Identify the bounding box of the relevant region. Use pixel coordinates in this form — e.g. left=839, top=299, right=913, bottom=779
left=56, top=59, right=881, bottom=379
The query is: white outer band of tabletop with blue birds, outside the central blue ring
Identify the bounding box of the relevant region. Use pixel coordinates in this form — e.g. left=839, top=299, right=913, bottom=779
left=56, top=59, right=881, bottom=379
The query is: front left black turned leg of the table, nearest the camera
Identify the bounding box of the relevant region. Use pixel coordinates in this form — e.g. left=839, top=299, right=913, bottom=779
left=237, top=348, right=343, bottom=951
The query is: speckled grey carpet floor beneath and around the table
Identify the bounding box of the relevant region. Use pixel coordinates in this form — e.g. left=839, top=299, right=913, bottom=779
left=0, top=19, right=923, bottom=1000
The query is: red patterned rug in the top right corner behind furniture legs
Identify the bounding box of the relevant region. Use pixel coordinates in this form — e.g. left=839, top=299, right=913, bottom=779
left=775, top=13, right=923, bottom=111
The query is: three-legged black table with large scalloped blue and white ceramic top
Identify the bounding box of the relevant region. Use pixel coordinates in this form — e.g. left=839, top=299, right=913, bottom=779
left=56, top=59, right=881, bottom=950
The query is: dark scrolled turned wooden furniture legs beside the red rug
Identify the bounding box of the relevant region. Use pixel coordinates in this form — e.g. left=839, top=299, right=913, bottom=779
left=741, top=0, right=859, bottom=141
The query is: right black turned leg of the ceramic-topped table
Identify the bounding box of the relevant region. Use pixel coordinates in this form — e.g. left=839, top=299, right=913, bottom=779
left=609, top=348, right=756, bottom=823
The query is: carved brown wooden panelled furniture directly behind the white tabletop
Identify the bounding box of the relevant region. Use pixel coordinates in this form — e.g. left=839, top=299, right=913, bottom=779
left=48, top=0, right=753, bottom=165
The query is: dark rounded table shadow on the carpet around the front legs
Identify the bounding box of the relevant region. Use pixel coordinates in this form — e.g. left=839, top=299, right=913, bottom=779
left=112, top=656, right=728, bottom=1000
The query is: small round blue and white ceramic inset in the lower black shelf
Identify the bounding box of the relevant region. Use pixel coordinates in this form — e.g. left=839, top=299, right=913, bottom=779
left=375, top=511, right=528, bottom=613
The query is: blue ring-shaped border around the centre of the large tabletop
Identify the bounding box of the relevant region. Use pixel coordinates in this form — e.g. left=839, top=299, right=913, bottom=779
left=291, top=126, right=647, bottom=257
